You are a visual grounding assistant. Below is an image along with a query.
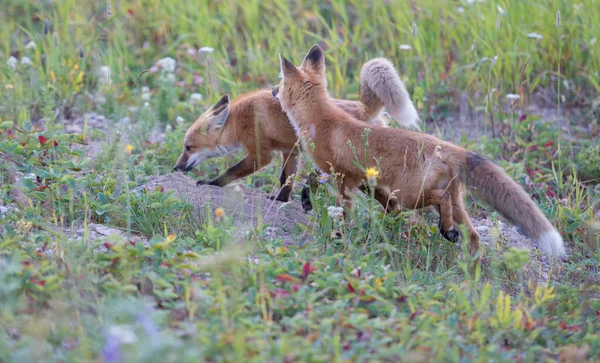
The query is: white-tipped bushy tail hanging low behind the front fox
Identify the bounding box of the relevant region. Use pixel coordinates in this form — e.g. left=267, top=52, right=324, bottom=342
left=465, top=152, right=567, bottom=259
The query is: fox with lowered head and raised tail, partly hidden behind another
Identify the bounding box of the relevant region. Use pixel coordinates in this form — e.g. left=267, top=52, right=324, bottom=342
left=173, top=58, right=419, bottom=210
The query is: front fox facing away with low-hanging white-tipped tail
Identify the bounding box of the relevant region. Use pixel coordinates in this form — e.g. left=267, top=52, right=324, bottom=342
left=272, top=45, right=566, bottom=258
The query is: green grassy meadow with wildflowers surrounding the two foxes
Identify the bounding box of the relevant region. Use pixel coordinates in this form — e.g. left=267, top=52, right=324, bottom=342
left=0, top=0, right=600, bottom=362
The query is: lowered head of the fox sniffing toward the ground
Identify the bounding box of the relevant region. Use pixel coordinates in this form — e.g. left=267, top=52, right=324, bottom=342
left=173, top=95, right=232, bottom=172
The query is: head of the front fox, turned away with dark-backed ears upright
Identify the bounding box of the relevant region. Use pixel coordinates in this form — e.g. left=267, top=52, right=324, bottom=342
left=272, top=44, right=328, bottom=112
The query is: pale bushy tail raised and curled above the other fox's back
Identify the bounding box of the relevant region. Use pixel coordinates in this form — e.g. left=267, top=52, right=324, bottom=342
left=360, top=58, right=419, bottom=129
